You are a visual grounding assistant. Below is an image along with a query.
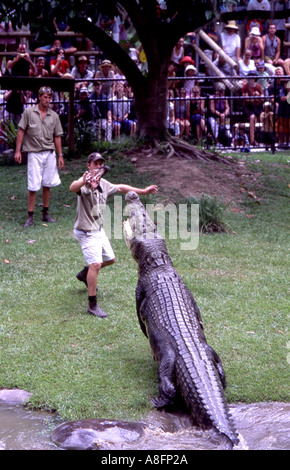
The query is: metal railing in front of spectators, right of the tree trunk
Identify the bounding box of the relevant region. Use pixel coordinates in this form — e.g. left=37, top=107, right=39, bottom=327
left=165, top=76, right=290, bottom=152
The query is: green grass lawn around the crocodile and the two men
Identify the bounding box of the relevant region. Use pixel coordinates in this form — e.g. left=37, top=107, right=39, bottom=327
left=0, top=149, right=290, bottom=419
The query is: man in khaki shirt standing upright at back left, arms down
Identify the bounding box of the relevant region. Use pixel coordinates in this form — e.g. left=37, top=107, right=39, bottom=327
left=14, top=86, right=64, bottom=227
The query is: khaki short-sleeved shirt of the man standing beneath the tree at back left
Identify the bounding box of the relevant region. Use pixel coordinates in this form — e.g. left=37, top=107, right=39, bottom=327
left=19, top=104, right=63, bottom=152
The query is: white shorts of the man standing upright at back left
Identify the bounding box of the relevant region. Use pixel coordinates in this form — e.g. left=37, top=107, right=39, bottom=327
left=27, top=150, right=61, bottom=191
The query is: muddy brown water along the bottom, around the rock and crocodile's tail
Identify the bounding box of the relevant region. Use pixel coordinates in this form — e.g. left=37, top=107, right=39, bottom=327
left=0, top=403, right=290, bottom=450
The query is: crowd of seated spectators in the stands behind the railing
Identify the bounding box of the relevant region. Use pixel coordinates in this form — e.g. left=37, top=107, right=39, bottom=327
left=0, top=0, right=290, bottom=152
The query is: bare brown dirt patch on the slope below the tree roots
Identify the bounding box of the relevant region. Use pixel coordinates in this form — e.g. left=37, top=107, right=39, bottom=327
left=129, top=151, right=256, bottom=204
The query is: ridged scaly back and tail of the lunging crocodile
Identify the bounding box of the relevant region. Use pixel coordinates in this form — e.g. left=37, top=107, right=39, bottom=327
left=141, top=268, right=235, bottom=440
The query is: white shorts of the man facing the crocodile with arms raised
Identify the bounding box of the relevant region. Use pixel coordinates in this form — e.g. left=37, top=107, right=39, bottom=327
left=74, top=228, right=115, bottom=264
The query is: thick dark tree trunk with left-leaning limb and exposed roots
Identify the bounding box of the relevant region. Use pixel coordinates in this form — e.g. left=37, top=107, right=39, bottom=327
left=71, top=18, right=231, bottom=160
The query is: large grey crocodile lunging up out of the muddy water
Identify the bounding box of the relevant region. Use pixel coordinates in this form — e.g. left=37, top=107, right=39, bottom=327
left=123, top=191, right=239, bottom=448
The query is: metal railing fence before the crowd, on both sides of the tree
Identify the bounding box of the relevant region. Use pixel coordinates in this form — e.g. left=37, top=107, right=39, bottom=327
left=0, top=76, right=290, bottom=152
